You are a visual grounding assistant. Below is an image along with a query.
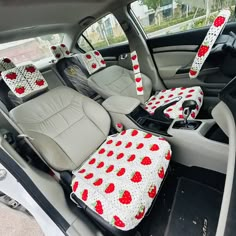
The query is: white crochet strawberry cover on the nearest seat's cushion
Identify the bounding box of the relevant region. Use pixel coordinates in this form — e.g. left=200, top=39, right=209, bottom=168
left=72, top=129, right=172, bottom=231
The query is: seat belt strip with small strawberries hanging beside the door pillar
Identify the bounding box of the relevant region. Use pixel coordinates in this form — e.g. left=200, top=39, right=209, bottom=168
left=130, top=51, right=145, bottom=103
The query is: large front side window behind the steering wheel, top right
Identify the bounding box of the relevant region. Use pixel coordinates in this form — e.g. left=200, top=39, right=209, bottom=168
left=130, top=0, right=235, bottom=38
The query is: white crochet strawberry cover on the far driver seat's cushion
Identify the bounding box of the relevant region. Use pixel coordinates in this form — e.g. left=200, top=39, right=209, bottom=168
left=145, top=86, right=203, bottom=119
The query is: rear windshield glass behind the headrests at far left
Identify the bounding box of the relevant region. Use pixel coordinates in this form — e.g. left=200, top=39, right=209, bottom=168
left=0, top=34, right=64, bottom=65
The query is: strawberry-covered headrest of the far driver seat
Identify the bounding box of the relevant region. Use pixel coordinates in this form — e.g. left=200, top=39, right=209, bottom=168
left=82, top=50, right=106, bottom=75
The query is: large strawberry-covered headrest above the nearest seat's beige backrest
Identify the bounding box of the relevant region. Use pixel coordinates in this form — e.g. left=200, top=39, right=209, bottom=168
left=2, top=64, right=48, bottom=98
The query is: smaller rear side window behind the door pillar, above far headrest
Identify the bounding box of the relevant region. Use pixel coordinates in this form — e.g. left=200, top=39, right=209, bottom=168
left=78, top=14, right=127, bottom=51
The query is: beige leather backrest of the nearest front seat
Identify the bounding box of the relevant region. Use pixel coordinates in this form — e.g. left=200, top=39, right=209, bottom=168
left=9, top=86, right=110, bottom=171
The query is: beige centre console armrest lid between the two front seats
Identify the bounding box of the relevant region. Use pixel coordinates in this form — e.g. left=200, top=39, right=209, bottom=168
left=102, top=96, right=140, bottom=115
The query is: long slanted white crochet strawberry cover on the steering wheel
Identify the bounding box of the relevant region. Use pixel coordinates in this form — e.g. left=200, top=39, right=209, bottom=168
left=189, top=10, right=230, bottom=79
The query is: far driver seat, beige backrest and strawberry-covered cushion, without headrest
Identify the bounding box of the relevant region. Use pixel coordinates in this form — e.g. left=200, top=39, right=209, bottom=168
left=88, top=65, right=203, bottom=119
